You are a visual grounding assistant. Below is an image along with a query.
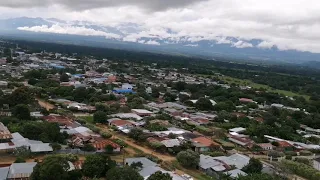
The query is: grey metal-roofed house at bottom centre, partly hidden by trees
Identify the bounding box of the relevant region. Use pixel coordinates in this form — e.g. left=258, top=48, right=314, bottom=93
left=125, top=157, right=185, bottom=180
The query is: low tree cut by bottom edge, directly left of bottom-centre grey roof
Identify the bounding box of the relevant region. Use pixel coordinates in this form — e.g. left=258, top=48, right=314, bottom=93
left=106, top=167, right=143, bottom=180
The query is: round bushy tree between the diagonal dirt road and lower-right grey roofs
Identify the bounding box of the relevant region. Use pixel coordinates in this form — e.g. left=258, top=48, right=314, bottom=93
left=177, top=150, right=200, bottom=168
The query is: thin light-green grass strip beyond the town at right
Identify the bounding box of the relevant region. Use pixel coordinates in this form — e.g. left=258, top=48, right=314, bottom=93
left=218, top=76, right=310, bottom=100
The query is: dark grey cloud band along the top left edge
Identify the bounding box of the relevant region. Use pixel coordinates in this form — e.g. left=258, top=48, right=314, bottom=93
left=0, top=0, right=207, bottom=11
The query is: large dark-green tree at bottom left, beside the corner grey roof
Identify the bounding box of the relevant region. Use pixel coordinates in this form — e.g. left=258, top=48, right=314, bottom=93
left=30, top=156, right=70, bottom=180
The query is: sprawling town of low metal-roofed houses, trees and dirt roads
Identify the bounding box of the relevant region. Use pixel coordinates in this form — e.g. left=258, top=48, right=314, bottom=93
left=0, top=40, right=320, bottom=180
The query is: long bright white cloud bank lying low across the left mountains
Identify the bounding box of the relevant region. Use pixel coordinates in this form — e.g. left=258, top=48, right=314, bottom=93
left=18, top=25, right=120, bottom=39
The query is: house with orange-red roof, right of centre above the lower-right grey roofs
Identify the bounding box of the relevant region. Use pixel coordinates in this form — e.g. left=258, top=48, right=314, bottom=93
left=191, top=136, right=220, bottom=152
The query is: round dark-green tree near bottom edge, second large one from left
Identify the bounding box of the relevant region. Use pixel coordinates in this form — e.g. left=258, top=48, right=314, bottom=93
left=82, top=154, right=116, bottom=178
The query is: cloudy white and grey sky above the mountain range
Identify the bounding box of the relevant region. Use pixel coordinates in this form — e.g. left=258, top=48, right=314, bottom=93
left=0, top=0, right=320, bottom=53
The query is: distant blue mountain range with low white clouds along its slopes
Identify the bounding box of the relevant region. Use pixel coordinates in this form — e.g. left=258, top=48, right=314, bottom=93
left=0, top=17, right=320, bottom=65
